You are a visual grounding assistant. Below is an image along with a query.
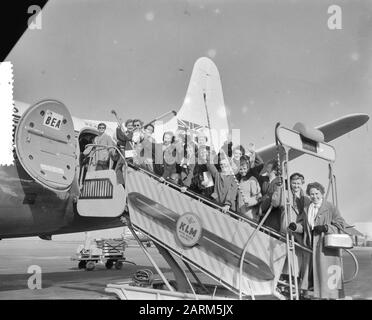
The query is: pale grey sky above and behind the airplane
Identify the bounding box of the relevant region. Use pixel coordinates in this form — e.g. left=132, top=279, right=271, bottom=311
left=3, top=0, right=372, bottom=238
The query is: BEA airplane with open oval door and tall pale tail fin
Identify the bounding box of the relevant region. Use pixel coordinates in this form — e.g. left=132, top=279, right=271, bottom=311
left=0, top=58, right=369, bottom=240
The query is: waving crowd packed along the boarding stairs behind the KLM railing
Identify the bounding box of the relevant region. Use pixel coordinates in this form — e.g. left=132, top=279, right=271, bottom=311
left=116, top=120, right=263, bottom=215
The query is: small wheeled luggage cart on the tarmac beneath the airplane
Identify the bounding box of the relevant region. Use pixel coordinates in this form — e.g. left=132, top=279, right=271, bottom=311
left=71, top=238, right=135, bottom=271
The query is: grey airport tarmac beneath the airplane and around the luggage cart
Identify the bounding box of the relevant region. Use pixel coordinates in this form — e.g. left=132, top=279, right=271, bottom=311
left=0, top=238, right=372, bottom=300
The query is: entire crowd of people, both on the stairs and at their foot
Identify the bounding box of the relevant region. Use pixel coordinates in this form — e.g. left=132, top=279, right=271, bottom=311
left=84, top=119, right=345, bottom=298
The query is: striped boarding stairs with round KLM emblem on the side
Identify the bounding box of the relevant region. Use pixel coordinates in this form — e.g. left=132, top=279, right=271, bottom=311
left=78, top=147, right=310, bottom=299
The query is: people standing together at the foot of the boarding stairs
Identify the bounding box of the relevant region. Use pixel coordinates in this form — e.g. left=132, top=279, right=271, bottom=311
left=266, top=173, right=346, bottom=299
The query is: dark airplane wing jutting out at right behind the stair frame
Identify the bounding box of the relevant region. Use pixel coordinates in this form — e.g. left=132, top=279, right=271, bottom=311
left=256, top=113, right=369, bottom=162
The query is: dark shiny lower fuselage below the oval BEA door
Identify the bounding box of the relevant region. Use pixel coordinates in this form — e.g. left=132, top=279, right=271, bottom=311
left=0, top=159, right=123, bottom=238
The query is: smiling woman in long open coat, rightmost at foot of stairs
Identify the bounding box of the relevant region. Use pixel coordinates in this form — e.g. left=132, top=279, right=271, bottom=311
left=288, top=182, right=345, bottom=299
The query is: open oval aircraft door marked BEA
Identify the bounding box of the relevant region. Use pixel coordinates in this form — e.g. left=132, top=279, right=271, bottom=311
left=15, top=100, right=76, bottom=192
